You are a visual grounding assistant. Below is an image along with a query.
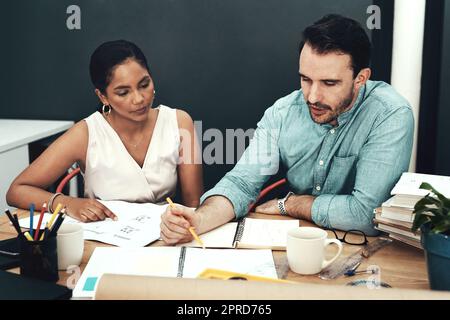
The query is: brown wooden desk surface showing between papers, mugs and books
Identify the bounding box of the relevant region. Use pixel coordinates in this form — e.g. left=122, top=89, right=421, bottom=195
left=0, top=210, right=429, bottom=290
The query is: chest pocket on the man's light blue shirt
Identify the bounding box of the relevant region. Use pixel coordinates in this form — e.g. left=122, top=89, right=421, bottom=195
left=322, top=155, right=357, bottom=194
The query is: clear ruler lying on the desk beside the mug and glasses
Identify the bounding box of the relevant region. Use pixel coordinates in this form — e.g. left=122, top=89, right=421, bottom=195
left=319, top=237, right=392, bottom=280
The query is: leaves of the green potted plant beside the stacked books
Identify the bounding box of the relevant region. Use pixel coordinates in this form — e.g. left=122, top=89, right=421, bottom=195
left=411, top=182, right=450, bottom=235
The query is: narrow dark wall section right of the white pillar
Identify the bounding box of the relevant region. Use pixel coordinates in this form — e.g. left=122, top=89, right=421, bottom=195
left=417, top=0, right=450, bottom=176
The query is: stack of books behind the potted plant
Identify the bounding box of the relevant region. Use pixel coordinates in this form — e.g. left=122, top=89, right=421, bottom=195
left=374, top=172, right=450, bottom=248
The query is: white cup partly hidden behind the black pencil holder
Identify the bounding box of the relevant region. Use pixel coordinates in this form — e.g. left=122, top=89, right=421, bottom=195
left=56, top=223, right=84, bottom=270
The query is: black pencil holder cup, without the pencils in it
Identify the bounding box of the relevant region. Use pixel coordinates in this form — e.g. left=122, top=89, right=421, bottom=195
left=18, top=234, right=59, bottom=282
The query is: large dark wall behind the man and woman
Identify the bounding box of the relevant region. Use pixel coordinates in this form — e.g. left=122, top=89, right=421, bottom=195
left=0, top=0, right=380, bottom=188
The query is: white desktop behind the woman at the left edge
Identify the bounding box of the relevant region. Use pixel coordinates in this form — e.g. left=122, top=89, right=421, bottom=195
left=0, top=119, right=73, bottom=152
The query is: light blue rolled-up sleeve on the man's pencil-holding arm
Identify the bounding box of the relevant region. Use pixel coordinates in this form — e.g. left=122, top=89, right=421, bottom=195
left=200, top=104, right=280, bottom=218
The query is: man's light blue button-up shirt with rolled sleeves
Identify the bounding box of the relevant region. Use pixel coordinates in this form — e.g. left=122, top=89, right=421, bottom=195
left=201, top=81, right=414, bottom=235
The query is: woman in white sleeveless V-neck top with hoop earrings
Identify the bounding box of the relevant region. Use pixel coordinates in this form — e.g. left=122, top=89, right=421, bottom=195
left=6, top=40, right=203, bottom=222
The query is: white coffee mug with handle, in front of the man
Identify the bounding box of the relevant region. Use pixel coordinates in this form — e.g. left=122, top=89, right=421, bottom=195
left=286, top=227, right=342, bottom=274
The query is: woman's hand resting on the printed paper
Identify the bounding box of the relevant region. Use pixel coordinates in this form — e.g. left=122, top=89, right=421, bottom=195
left=66, top=198, right=117, bottom=222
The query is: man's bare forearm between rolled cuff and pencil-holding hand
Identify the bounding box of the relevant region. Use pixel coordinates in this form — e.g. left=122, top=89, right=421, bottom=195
left=196, top=196, right=235, bottom=234
